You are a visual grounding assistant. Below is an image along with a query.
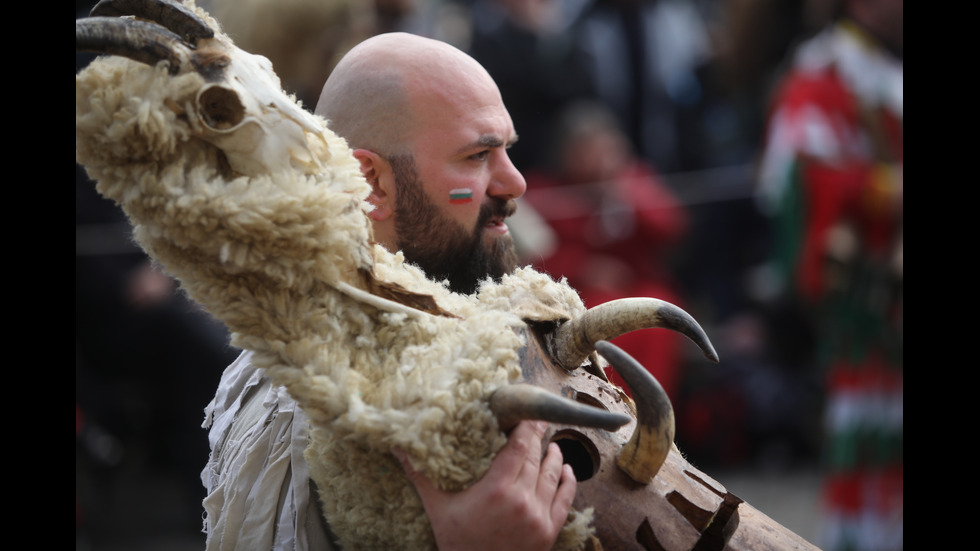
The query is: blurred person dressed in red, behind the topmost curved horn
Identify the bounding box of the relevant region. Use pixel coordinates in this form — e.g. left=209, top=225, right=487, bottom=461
left=525, top=103, right=687, bottom=402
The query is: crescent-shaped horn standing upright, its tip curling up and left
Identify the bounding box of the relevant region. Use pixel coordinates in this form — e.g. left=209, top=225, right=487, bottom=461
left=595, top=341, right=674, bottom=484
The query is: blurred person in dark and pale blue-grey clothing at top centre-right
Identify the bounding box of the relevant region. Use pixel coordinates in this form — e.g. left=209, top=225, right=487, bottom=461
left=568, top=0, right=712, bottom=173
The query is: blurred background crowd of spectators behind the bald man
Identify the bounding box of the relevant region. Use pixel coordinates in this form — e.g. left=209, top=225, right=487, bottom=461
left=75, top=0, right=904, bottom=551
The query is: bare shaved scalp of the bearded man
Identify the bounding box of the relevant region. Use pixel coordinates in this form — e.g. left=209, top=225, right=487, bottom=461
left=316, top=33, right=499, bottom=156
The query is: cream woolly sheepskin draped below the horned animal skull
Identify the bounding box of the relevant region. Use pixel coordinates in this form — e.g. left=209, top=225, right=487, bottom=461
left=75, top=5, right=592, bottom=550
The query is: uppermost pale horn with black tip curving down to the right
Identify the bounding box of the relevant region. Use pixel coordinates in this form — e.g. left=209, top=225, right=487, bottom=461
left=551, top=297, right=718, bottom=370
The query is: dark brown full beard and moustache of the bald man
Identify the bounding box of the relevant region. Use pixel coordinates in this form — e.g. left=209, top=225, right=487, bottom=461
left=388, top=155, right=517, bottom=294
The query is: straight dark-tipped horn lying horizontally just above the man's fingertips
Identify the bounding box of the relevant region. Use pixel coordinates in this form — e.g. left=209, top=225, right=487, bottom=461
left=490, top=383, right=630, bottom=431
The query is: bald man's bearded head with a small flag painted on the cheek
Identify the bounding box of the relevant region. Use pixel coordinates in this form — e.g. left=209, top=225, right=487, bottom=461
left=316, top=33, right=526, bottom=293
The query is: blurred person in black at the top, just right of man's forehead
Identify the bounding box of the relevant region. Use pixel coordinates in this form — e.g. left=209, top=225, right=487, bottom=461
left=468, top=0, right=595, bottom=171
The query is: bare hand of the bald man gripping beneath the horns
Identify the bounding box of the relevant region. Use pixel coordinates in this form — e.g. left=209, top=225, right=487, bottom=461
left=396, top=421, right=577, bottom=551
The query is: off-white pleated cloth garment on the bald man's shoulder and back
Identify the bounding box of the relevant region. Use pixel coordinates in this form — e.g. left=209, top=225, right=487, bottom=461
left=201, top=351, right=337, bottom=551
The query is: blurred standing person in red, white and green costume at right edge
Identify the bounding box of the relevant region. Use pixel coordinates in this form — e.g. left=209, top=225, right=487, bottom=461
left=761, top=0, right=904, bottom=551
